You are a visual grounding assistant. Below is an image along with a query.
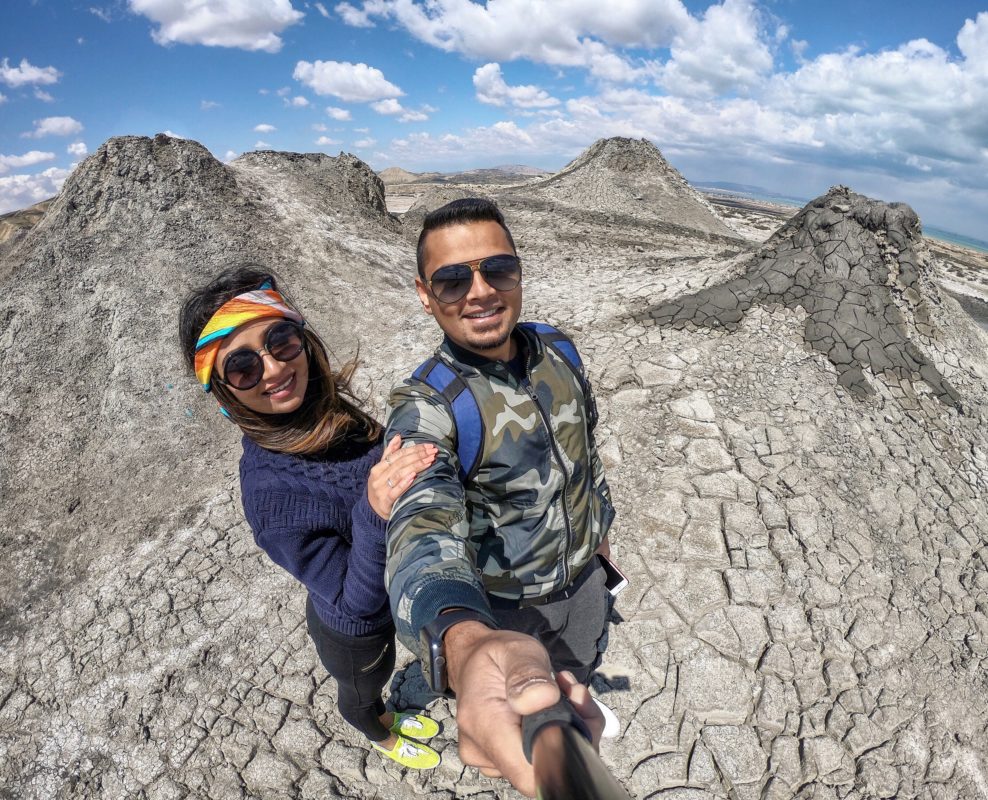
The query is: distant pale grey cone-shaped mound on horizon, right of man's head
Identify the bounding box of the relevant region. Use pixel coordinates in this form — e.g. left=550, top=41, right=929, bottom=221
left=520, top=137, right=738, bottom=237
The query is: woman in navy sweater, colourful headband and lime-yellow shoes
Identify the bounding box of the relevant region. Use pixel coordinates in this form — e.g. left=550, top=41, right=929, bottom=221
left=179, top=267, right=439, bottom=769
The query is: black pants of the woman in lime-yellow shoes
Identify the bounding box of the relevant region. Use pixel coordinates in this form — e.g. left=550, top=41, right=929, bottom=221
left=305, top=599, right=395, bottom=742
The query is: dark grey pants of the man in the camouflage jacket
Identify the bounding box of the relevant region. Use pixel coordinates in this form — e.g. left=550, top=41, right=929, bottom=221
left=491, top=557, right=610, bottom=684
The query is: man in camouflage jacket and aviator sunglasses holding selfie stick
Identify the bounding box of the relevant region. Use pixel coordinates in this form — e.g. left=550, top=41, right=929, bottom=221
left=387, top=198, right=614, bottom=794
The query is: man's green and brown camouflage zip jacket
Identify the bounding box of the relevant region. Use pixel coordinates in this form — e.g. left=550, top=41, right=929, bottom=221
left=385, top=326, right=614, bottom=653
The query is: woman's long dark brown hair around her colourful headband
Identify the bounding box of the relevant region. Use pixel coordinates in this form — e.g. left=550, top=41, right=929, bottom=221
left=179, top=265, right=381, bottom=456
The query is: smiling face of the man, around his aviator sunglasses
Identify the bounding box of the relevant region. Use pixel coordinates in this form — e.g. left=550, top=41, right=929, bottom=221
left=415, top=220, right=521, bottom=361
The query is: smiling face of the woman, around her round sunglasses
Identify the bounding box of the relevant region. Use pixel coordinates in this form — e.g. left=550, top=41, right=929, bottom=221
left=216, top=318, right=309, bottom=414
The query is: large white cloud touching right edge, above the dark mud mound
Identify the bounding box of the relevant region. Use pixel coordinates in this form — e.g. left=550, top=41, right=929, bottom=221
left=759, top=18, right=988, bottom=178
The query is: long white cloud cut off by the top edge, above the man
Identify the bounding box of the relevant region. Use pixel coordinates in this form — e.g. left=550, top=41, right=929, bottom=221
left=336, top=0, right=691, bottom=80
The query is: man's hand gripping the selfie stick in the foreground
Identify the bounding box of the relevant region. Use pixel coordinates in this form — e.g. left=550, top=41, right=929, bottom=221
left=444, top=622, right=604, bottom=797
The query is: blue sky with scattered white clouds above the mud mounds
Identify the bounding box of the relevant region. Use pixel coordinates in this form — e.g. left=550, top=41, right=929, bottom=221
left=0, top=0, right=988, bottom=239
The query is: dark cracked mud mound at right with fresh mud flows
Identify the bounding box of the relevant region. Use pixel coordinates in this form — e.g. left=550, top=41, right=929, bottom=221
left=635, top=187, right=967, bottom=406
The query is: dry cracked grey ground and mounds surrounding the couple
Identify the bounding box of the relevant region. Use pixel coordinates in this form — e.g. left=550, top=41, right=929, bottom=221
left=0, top=137, right=988, bottom=800
